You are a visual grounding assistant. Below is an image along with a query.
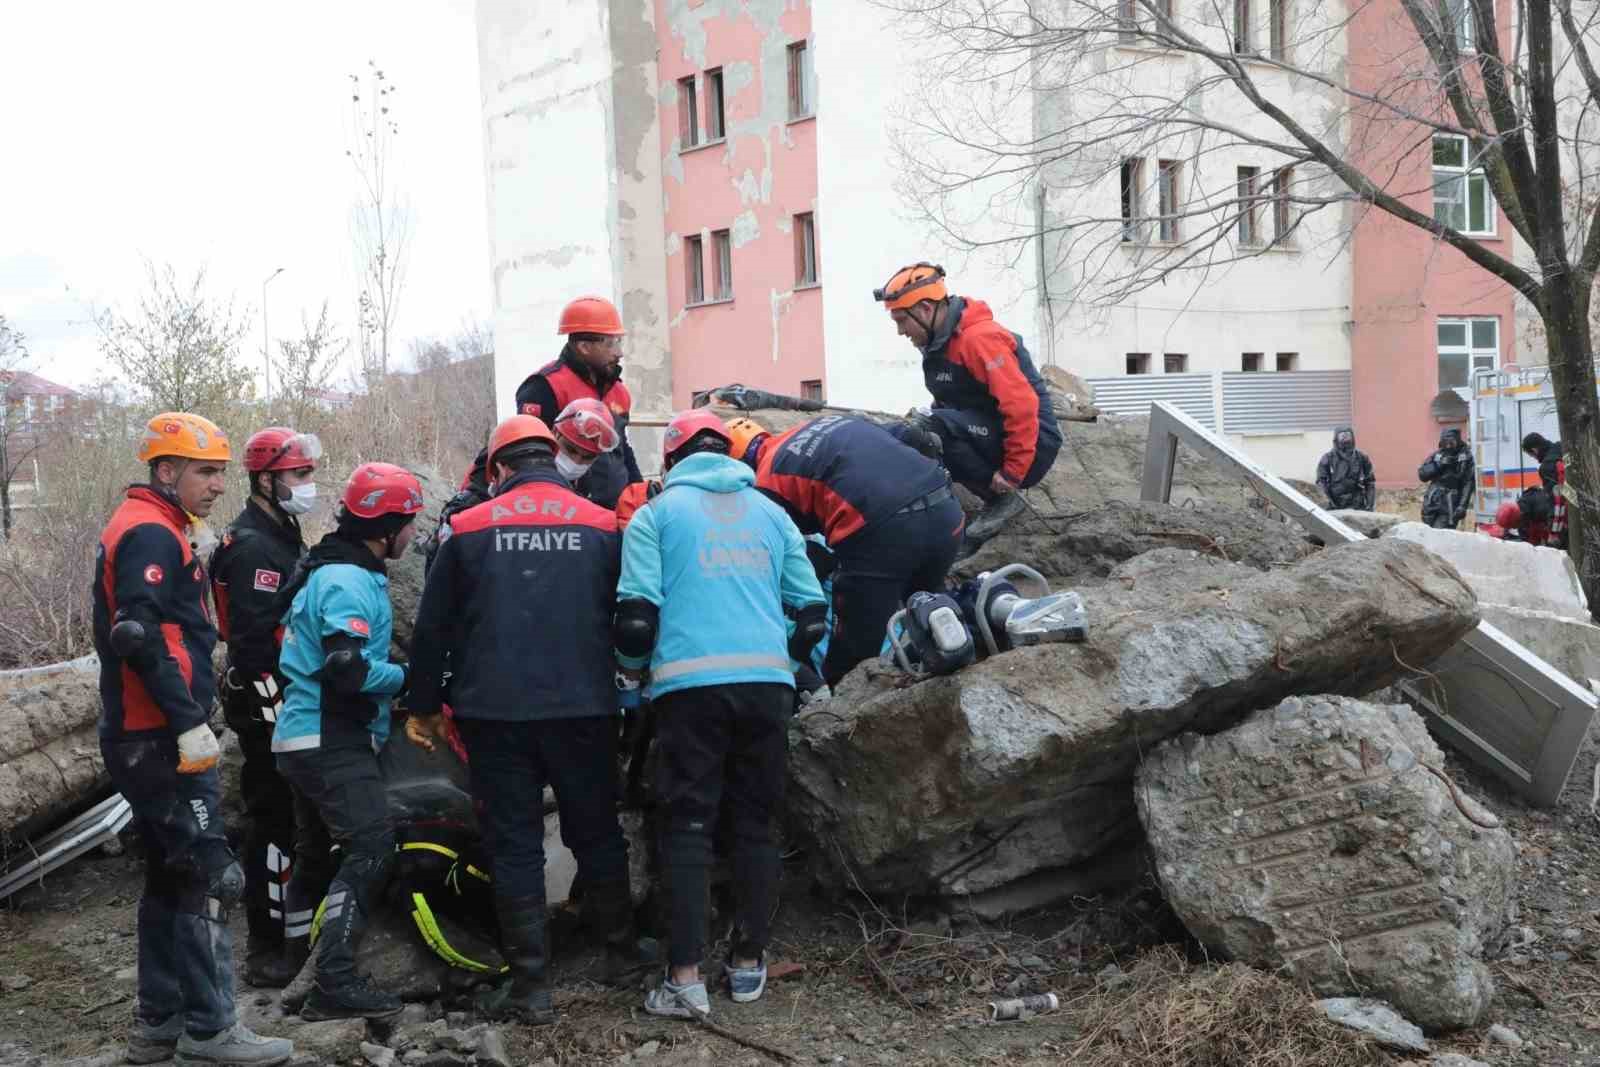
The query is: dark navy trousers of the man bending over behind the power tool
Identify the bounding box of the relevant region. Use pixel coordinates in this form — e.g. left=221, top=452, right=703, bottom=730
left=822, top=498, right=965, bottom=685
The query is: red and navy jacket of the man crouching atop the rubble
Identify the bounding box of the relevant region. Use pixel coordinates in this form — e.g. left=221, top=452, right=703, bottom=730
left=922, top=296, right=1061, bottom=485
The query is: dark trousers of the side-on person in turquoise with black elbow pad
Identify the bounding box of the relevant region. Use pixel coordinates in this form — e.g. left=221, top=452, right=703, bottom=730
left=278, top=747, right=395, bottom=987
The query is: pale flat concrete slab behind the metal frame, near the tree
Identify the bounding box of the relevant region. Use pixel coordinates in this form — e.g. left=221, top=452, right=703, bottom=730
left=1386, top=523, right=1589, bottom=619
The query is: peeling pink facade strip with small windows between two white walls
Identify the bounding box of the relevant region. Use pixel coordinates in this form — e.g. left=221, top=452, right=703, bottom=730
left=654, top=0, right=826, bottom=408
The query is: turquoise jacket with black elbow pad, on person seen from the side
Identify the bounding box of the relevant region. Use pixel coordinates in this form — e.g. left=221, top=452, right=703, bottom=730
left=272, top=549, right=405, bottom=752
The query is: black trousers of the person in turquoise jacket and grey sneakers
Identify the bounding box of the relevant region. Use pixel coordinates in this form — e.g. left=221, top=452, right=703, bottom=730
left=654, top=683, right=795, bottom=966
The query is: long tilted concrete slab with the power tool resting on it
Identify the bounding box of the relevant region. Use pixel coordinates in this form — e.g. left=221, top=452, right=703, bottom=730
left=789, top=541, right=1477, bottom=894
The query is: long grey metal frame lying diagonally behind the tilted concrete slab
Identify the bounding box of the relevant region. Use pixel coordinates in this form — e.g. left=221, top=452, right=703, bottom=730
left=1141, top=402, right=1597, bottom=805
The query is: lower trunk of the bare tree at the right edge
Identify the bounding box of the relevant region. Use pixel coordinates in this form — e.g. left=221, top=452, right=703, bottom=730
left=1542, top=275, right=1600, bottom=613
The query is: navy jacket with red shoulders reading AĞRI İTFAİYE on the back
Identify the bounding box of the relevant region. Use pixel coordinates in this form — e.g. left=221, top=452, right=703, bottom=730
left=408, top=467, right=622, bottom=721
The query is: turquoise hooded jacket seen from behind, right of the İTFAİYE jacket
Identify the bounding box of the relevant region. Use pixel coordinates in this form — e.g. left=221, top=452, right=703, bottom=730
left=616, top=453, right=822, bottom=697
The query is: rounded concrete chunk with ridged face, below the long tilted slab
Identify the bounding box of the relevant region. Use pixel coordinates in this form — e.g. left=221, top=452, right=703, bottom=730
left=1134, top=694, right=1517, bottom=1032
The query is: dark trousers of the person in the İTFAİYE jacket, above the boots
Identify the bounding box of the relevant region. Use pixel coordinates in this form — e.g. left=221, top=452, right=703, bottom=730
left=456, top=713, right=627, bottom=901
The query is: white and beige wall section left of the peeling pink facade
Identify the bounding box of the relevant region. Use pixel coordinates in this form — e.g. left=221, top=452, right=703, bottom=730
left=477, top=0, right=670, bottom=425
